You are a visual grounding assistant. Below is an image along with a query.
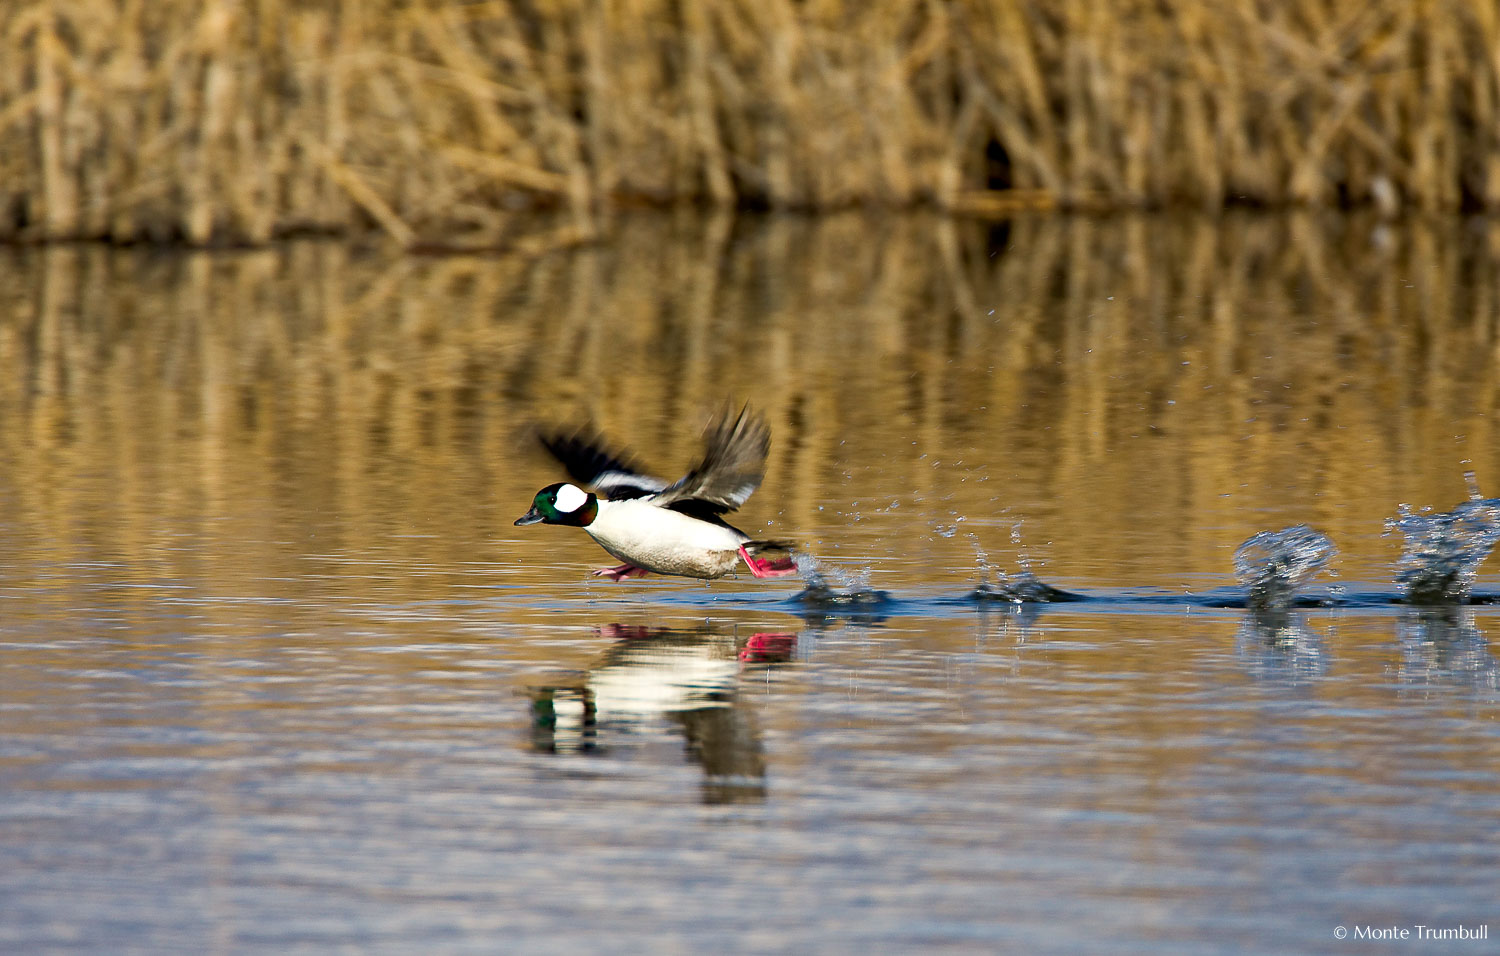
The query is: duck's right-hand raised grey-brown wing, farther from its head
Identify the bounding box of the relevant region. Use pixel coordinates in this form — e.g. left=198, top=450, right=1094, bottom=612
left=651, top=405, right=771, bottom=516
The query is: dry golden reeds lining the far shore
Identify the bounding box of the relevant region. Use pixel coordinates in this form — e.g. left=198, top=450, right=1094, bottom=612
left=0, top=0, right=1500, bottom=249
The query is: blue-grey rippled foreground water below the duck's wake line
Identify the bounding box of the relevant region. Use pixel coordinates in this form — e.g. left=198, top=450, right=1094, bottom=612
left=0, top=587, right=1500, bottom=951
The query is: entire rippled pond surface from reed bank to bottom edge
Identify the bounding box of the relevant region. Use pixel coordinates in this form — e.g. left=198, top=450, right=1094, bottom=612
left=0, top=216, right=1500, bottom=953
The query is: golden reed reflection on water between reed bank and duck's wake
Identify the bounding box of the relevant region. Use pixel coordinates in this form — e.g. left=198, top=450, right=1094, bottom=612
left=0, top=215, right=1500, bottom=594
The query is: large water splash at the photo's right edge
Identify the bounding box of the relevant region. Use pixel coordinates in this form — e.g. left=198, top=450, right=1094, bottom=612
left=1386, top=471, right=1500, bottom=605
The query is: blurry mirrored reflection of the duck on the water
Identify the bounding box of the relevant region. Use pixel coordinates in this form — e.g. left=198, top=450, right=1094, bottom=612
left=530, top=624, right=798, bottom=803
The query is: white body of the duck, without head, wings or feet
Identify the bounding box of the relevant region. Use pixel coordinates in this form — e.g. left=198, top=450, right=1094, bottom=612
left=584, top=498, right=750, bottom=578
